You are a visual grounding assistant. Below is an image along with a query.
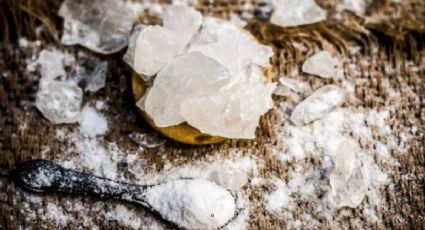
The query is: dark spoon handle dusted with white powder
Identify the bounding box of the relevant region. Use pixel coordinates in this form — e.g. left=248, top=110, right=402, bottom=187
left=11, top=160, right=145, bottom=202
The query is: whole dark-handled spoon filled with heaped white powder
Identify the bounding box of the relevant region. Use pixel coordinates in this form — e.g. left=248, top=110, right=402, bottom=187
left=11, top=160, right=236, bottom=229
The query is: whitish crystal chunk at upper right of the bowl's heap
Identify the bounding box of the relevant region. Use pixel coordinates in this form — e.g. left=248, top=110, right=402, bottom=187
left=189, top=18, right=273, bottom=75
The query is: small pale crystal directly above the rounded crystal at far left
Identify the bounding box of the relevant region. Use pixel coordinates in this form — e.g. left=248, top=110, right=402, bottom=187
left=37, top=50, right=66, bottom=81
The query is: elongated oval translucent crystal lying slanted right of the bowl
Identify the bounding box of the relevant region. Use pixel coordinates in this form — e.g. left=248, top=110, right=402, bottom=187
left=290, top=85, right=345, bottom=126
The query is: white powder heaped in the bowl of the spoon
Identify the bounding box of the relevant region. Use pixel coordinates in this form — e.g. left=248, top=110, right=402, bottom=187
left=143, top=179, right=236, bottom=230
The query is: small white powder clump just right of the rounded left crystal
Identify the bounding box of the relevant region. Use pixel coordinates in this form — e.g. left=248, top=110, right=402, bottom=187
left=79, top=105, right=108, bottom=137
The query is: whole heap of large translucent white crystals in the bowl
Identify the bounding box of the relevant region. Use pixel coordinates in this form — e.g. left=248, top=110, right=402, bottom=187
left=126, top=6, right=275, bottom=139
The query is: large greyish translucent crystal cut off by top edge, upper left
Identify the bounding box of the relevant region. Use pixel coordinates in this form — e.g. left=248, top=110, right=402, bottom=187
left=59, top=0, right=134, bottom=54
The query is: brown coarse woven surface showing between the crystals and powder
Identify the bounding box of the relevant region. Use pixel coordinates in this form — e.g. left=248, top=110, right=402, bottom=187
left=0, top=0, right=425, bottom=229
